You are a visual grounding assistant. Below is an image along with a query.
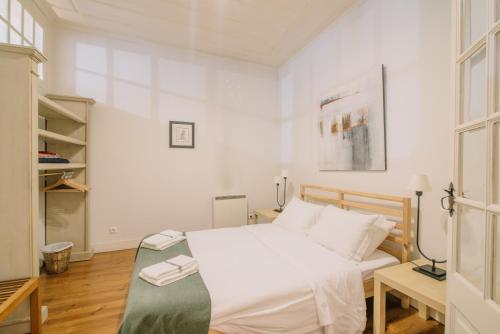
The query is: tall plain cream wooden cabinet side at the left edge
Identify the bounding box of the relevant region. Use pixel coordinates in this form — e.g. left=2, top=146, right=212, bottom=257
left=0, top=43, right=47, bottom=288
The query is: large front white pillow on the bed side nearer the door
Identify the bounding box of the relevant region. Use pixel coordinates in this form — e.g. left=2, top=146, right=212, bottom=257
left=309, top=205, right=379, bottom=261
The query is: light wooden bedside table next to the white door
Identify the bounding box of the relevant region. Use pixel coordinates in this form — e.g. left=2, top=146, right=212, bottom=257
left=373, top=259, right=446, bottom=334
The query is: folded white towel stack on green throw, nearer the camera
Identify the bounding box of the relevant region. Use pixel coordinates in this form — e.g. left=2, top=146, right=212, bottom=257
left=139, top=255, right=198, bottom=286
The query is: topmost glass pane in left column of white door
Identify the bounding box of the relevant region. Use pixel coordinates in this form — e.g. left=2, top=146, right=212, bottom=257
left=461, top=0, right=488, bottom=51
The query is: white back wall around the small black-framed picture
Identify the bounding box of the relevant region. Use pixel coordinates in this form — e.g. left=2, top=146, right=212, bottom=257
left=52, top=27, right=280, bottom=250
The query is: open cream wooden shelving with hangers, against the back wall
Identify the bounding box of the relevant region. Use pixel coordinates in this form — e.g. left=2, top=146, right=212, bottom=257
left=37, top=95, right=95, bottom=261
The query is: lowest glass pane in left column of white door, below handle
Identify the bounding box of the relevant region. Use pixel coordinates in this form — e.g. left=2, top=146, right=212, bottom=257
left=457, top=206, right=486, bottom=291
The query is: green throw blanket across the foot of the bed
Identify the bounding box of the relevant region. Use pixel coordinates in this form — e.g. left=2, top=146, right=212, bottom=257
left=119, top=240, right=211, bottom=334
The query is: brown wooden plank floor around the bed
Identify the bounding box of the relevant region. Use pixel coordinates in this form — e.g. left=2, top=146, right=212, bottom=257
left=41, top=250, right=444, bottom=334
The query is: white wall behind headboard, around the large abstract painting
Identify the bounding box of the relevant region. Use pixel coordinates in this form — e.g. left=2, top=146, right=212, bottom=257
left=280, top=0, right=451, bottom=257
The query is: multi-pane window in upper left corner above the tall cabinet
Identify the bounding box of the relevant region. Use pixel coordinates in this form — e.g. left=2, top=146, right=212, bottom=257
left=0, top=0, right=44, bottom=80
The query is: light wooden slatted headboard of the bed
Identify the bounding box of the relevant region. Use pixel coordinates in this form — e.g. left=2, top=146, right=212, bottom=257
left=300, top=184, right=411, bottom=263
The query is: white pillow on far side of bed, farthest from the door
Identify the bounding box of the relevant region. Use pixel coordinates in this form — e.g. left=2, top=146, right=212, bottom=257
left=273, top=197, right=323, bottom=235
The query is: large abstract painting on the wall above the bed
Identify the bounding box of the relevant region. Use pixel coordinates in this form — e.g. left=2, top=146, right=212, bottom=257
left=318, top=65, right=387, bottom=171
